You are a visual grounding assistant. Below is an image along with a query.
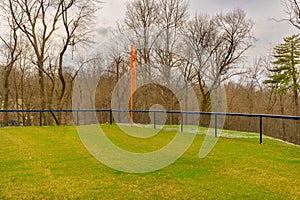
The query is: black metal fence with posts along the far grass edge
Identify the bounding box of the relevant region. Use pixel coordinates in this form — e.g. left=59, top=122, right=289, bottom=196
left=0, top=109, right=300, bottom=144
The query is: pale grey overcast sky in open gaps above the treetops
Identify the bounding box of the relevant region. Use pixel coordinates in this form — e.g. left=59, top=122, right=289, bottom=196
left=98, top=0, right=300, bottom=60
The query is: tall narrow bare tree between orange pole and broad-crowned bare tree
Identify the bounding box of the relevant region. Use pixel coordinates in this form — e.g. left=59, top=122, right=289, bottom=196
left=154, top=0, right=188, bottom=124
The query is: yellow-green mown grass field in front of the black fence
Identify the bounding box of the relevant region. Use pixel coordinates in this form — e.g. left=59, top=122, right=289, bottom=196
left=0, top=125, right=300, bottom=199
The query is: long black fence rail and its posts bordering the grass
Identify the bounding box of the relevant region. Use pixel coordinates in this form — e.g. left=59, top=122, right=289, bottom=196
left=0, top=109, right=300, bottom=144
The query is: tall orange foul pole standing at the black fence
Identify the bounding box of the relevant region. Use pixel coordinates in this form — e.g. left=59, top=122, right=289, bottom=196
left=130, top=45, right=136, bottom=126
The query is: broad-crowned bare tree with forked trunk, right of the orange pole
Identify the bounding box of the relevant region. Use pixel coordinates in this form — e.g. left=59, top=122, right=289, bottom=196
left=184, top=10, right=253, bottom=110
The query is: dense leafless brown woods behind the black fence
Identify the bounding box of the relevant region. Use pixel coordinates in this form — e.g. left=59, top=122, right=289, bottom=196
left=0, top=0, right=300, bottom=144
